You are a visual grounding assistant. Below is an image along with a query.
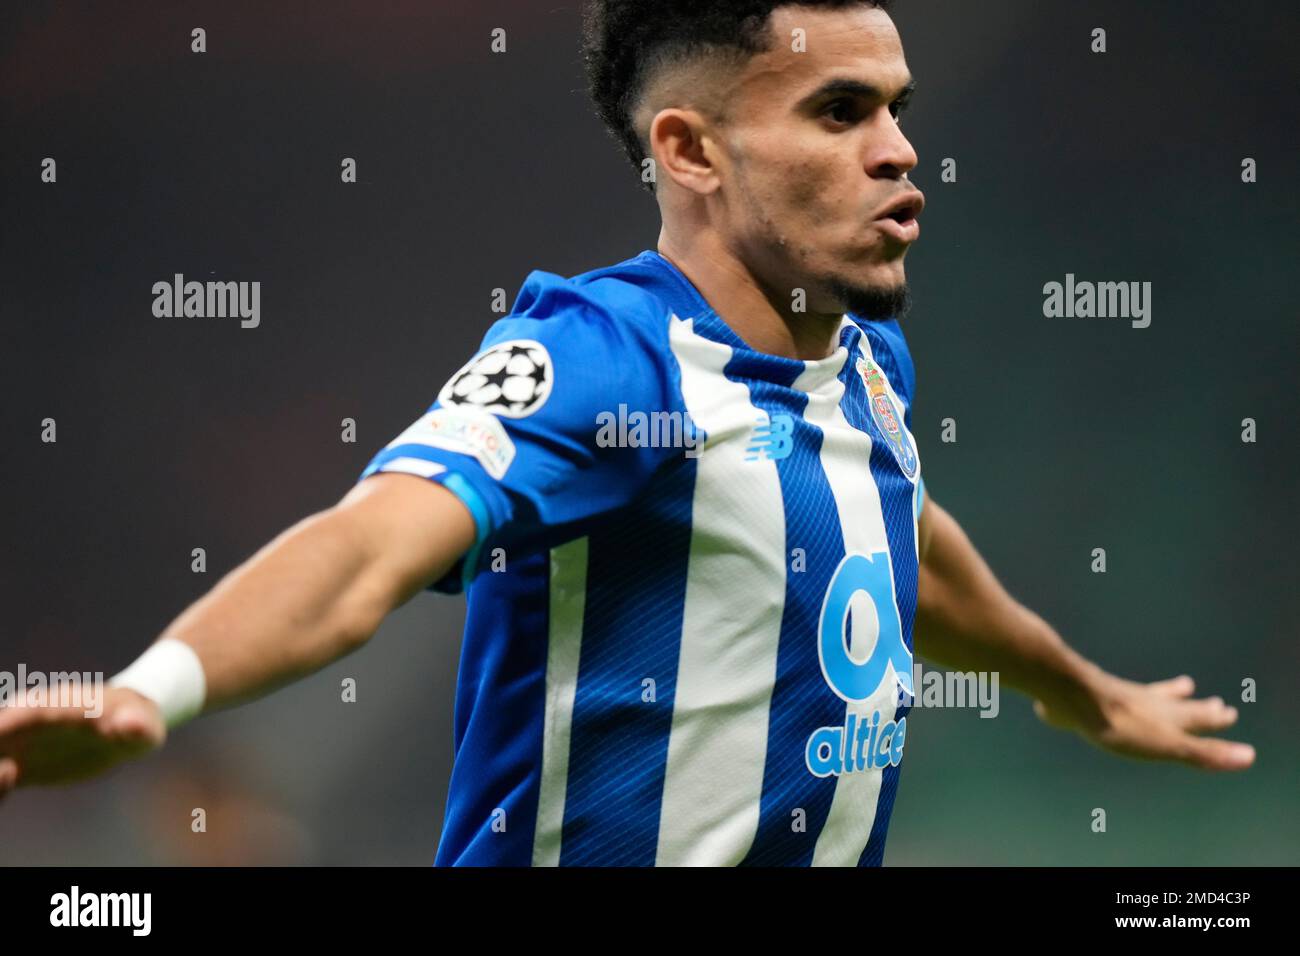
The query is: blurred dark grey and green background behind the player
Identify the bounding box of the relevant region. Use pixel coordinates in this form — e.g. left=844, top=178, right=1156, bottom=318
left=0, top=0, right=1300, bottom=865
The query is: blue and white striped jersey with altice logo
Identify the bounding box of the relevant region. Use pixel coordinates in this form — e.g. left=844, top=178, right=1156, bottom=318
left=361, top=251, right=924, bottom=865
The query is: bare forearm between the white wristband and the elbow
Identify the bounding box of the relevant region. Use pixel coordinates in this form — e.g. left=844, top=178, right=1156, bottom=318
left=152, top=510, right=387, bottom=710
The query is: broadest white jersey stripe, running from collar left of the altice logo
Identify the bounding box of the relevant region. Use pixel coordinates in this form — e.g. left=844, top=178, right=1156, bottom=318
left=655, top=315, right=787, bottom=866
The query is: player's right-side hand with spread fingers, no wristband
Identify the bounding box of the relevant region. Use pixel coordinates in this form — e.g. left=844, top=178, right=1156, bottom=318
left=1034, top=674, right=1255, bottom=770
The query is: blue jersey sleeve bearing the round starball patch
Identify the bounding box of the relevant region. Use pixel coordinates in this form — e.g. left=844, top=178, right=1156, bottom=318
left=358, top=272, right=681, bottom=592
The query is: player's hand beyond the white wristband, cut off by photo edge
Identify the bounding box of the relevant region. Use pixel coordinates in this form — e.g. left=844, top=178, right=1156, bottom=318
left=0, top=687, right=166, bottom=800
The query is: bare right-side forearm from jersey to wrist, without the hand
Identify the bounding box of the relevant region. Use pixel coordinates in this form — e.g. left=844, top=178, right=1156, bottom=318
left=914, top=502, right=1102, bottom=698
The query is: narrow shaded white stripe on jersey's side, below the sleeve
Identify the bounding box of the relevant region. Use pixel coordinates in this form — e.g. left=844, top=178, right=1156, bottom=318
left=533, top=537, right=588, bottom=866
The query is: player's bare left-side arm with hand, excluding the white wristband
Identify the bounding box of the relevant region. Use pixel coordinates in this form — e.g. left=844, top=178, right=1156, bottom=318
left=0, top=473, right=475, bottom=796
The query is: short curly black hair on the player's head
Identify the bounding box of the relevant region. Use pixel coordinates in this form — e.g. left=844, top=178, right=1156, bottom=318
left=582, top=0, right=891, bottom=193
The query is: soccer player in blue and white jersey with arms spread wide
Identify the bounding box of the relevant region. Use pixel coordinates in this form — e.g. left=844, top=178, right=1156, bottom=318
left=0, top=0, right=1253, bottom=865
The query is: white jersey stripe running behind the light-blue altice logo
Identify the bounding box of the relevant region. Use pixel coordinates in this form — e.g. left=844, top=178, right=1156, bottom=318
left=794, top=316, right=901, bottom=866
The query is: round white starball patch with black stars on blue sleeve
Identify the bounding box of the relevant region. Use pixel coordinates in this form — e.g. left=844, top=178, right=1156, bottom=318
left=438, top=338, right=555, bottom=419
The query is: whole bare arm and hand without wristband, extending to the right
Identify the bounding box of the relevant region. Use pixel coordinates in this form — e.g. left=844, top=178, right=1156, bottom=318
left=913, top=496, right=1255, bottom=770
